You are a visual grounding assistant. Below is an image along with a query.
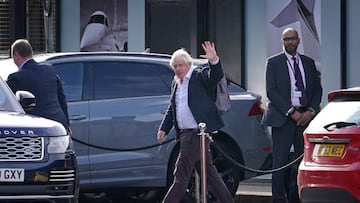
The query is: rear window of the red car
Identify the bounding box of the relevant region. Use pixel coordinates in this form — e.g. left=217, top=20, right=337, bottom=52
left=309, top=101, right=360, bottom=128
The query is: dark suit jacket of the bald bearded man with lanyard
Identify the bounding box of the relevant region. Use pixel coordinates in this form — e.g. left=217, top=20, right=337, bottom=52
left=263, top=53, right=322, bottom=127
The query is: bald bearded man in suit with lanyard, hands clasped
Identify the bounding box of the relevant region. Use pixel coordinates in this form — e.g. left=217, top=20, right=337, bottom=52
left=263, top=28, right=322, bottom=203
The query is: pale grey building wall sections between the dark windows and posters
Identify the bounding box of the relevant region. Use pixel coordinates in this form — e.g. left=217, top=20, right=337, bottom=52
left=60, top=0, right=360, bottom=106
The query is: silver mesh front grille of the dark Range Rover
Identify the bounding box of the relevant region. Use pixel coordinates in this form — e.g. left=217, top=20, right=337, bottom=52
left=0, top=137, right=44, bottom=161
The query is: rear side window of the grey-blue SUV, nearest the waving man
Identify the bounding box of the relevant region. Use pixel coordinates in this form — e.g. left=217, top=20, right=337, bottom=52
left=92, top=62, right=174, bottom=99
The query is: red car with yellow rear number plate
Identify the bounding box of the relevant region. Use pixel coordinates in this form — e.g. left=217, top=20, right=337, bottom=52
left=298, top=87, right=360, bottom=203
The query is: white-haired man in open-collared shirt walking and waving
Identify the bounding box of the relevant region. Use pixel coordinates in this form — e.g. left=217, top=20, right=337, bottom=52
left=157, top=41, right=233, bottom=203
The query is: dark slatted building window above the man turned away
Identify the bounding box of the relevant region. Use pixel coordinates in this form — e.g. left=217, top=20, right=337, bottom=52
left=0, top=0, right=58, bottom=58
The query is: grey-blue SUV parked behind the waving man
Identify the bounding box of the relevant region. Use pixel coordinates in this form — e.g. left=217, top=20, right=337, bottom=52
left=0, top=52, right=271, bottom=202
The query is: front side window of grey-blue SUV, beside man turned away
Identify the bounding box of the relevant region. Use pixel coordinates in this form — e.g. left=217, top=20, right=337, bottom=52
left=54, top=63, right=84, bottom=102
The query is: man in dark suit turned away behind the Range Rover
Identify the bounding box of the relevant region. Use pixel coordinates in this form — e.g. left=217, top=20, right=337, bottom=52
left=7, top=39, right=70, bottom=131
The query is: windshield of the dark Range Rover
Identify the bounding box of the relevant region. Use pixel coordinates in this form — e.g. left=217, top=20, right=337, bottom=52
left=0, top=79, right=24, bottom=113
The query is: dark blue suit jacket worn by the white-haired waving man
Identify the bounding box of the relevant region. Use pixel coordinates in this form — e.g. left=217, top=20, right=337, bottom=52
left=160, top=61, right=224, bottom=135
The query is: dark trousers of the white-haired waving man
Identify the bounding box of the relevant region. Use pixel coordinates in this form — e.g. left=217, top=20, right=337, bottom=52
left=163, top=132, right=234, bottom=203
